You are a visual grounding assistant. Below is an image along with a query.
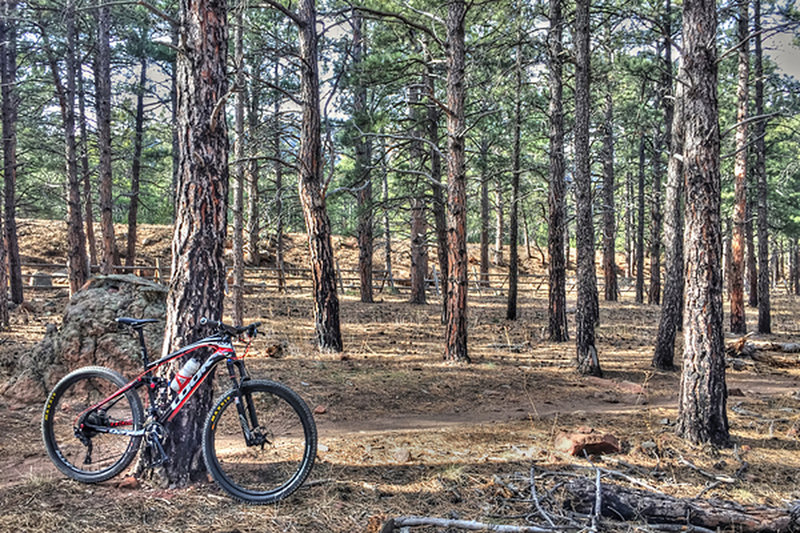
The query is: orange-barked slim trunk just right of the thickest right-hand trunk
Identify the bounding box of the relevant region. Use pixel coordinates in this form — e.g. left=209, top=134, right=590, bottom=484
left=728, top=2, right=750, bottom=334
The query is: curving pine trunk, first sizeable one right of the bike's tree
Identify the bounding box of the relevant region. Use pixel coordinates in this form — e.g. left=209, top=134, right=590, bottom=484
left=298, top=0, right=342, bottom=352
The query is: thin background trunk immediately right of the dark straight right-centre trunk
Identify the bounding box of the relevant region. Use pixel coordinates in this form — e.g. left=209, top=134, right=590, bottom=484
left=602, top=69, right=619, bottom=302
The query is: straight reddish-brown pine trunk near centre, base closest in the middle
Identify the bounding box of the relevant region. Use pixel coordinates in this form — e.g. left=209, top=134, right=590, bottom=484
left=445, top=0, right=470, bottom=362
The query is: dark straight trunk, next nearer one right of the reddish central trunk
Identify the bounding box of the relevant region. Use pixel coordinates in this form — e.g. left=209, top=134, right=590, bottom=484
left=575, top=0, right=602, bottom=376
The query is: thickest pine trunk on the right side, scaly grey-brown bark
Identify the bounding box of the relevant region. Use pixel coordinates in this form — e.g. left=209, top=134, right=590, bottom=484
left=676, top=0, right=729, bottom=446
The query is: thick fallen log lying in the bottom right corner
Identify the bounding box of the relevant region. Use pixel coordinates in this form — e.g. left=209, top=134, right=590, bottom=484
left=564, top=478, right=800, bottom=533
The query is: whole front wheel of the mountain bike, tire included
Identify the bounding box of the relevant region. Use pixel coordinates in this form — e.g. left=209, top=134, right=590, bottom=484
left=203, top=381, right=317, bottom=504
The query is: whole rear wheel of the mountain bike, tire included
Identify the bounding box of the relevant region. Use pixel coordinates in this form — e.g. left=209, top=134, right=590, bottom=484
left=42, top=366, right=144, bottom=483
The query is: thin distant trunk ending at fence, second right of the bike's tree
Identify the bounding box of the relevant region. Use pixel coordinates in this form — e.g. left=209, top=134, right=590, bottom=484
left=245, top=72, right=261, bottom=267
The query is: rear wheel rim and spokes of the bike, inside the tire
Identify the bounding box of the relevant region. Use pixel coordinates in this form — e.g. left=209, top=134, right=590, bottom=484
left=46, top=375, right=140, bottom=478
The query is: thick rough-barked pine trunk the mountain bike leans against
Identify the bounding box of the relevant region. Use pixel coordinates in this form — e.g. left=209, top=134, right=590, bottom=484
left=163, top=0, right=228, bottom=485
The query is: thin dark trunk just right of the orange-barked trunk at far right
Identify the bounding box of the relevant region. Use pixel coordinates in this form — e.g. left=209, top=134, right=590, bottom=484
left=753, top=0, right=772, bottom=333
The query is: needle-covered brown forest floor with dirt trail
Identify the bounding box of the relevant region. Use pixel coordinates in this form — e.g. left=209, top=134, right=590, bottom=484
left=0, top=218, right=800, bottom=533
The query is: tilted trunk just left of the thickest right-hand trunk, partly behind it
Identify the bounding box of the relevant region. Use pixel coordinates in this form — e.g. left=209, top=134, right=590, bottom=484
left=653, top=14, right=684, bottom=370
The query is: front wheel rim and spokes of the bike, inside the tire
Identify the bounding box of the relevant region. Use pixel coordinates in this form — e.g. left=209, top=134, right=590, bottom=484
left=208, top=390, right=310, bottom=499
